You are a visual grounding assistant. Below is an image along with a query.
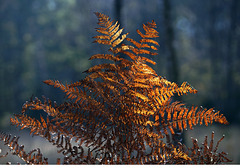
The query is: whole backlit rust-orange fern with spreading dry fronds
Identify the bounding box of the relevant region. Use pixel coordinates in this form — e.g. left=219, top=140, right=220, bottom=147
left=0, top=13, right=230, bottom=164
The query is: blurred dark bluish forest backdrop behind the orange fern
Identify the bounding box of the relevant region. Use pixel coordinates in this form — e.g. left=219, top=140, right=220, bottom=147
left=0, top=0, right=240, bottom=163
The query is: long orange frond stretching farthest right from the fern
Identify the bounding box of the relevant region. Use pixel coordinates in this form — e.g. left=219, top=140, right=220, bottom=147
left=153, top=102, right=228, bottom=134
